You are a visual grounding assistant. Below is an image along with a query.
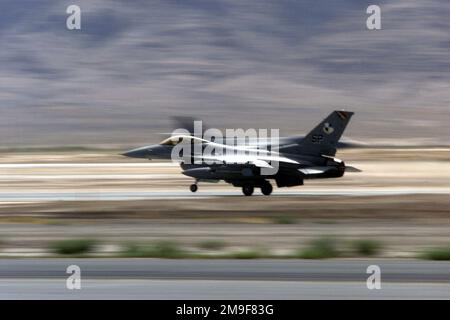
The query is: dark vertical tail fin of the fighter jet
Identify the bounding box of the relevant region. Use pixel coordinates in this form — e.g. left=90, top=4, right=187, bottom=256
left=300, top=111, right=353, bottom=156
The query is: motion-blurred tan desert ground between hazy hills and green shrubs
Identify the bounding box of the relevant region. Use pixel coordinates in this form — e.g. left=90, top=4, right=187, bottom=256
left=0, top=148, right=450, bottom=257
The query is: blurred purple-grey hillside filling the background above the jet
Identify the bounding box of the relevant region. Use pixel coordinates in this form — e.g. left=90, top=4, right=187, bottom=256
left=0, top=0, right=450, bottom=147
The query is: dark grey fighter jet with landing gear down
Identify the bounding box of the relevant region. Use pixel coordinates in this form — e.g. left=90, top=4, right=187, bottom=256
left=123, top=111, right=358, bottom=196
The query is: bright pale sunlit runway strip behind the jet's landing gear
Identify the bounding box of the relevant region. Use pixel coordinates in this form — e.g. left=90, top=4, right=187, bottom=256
left=0, top=159, right=450, bottom=203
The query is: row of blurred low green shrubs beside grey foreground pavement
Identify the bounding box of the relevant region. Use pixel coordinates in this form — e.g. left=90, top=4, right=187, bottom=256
left=41, top=237, right=394, bottom=260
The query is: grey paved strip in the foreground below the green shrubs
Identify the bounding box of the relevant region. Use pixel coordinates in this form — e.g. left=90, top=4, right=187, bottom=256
left=0, top=259, right=450, bottom=299
